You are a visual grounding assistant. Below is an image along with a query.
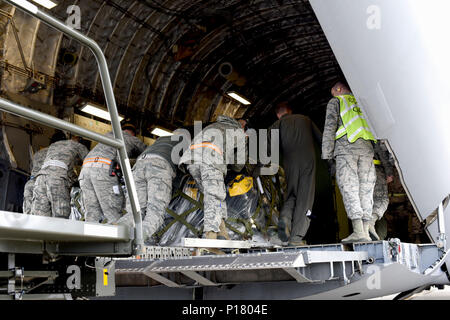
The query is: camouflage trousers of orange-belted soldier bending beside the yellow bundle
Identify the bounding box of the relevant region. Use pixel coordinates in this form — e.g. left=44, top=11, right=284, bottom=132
left=187, top=164, right=227, bottom=232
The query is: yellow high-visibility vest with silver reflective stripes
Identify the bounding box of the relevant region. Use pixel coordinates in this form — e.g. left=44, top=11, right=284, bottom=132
left=335, top=94, right=377, bottom=143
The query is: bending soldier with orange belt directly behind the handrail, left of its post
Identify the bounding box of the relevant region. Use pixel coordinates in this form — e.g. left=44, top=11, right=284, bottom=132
left=78, top=124, right=146, bottom=223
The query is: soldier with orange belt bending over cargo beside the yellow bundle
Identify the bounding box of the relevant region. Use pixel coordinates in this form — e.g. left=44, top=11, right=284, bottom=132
left=180, top=115, right=246, bottom=239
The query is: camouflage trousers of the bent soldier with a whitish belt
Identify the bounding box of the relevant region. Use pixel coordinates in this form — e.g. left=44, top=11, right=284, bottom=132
left=31, top=174, right=71, bottom=218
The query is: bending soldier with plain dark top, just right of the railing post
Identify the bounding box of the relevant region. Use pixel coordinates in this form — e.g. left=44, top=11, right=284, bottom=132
left=117, top=137, right=185, bottom=240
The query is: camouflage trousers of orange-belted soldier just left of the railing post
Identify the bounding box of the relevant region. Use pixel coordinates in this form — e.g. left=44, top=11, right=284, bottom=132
left=79, top=167, right=124, bottom=223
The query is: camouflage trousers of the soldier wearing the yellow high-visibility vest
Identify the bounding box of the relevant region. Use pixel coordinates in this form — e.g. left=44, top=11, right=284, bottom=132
left=336, top=155, right=376, bottom=220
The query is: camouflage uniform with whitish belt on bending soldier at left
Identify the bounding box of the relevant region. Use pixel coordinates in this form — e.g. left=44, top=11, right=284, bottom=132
left=31, top=140, right=88, bottom=218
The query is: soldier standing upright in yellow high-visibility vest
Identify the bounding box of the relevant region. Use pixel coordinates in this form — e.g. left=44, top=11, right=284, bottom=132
left=322, top=82, right=376, bottom=242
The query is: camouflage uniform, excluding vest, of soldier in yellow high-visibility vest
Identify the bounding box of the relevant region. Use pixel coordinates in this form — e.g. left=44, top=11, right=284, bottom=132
left=322, top=97, right=376, bottom=221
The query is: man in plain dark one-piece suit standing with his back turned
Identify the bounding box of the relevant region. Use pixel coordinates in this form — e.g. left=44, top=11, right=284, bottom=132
left=270, top=102, right=322, bottom=246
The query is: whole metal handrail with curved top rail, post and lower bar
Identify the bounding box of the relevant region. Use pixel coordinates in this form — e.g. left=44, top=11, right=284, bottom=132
left=0, top=0, right=144, bottom=253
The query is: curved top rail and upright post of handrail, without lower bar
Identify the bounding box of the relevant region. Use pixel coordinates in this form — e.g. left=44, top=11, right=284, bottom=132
left=3, top=0, right=144, bottom=253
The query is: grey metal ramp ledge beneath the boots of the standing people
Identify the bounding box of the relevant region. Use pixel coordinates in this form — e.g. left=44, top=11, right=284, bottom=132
left=116, top=244, right=369, bottom=287
